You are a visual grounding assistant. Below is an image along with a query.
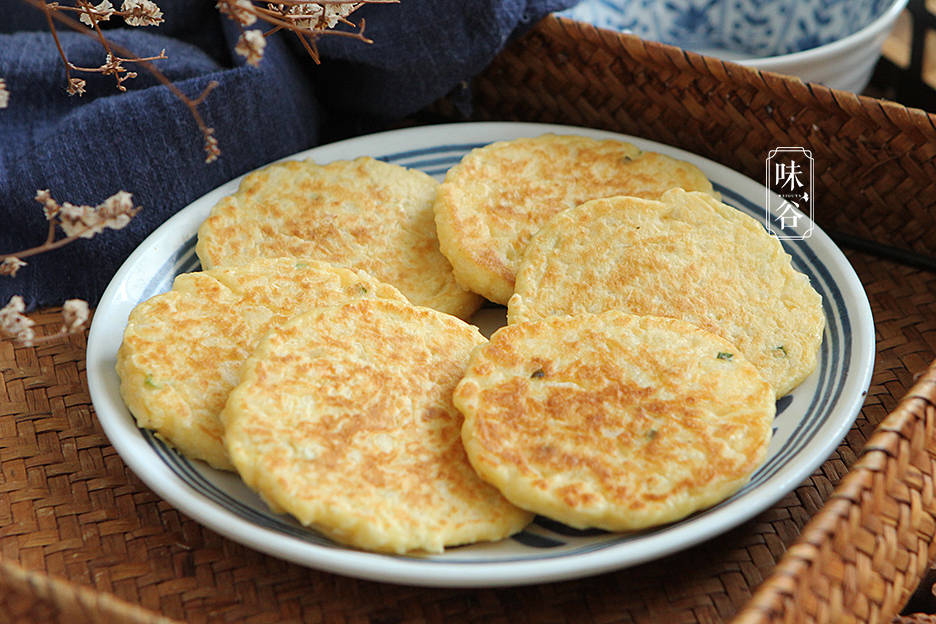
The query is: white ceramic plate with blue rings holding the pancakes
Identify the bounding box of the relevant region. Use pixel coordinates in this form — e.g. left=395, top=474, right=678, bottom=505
left=87, top=123, right=875, bottom=586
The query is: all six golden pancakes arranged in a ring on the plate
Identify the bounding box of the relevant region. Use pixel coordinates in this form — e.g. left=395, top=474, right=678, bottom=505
left=117, top=135, right=824, bottom=553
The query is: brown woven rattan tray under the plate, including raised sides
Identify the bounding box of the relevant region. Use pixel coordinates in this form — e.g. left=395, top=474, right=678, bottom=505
left=0, top=14, right=936, bottom=624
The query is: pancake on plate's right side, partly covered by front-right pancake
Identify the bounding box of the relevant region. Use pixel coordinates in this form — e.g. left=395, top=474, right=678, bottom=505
left=507, top=189, right=825, bottom=397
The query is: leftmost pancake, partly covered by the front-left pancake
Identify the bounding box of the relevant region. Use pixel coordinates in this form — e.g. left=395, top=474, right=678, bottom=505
left=117, top=258, right=406, bottom=470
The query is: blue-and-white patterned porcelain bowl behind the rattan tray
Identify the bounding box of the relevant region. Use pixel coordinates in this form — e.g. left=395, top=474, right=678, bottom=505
left=559, top=0, right=907, bottom=92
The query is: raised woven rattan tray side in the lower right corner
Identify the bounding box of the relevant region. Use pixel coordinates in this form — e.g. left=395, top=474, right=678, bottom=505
left=738, top=356, right=936, bottom=624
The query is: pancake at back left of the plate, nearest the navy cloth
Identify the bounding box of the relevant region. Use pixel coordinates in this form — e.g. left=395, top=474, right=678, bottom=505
left=195, top=157, right=481, bottom=318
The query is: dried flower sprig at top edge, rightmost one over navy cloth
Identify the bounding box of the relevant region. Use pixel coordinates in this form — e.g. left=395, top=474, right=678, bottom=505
left=217, top=0, right=399, bottom=66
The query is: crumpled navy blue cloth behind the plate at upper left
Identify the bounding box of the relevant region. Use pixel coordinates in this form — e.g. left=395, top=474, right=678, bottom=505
left=0, top=0, right=572, bottom=308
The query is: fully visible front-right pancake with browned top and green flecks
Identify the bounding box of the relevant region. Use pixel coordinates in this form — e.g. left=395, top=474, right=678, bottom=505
left=453, top=310, right=775, bottom=531
